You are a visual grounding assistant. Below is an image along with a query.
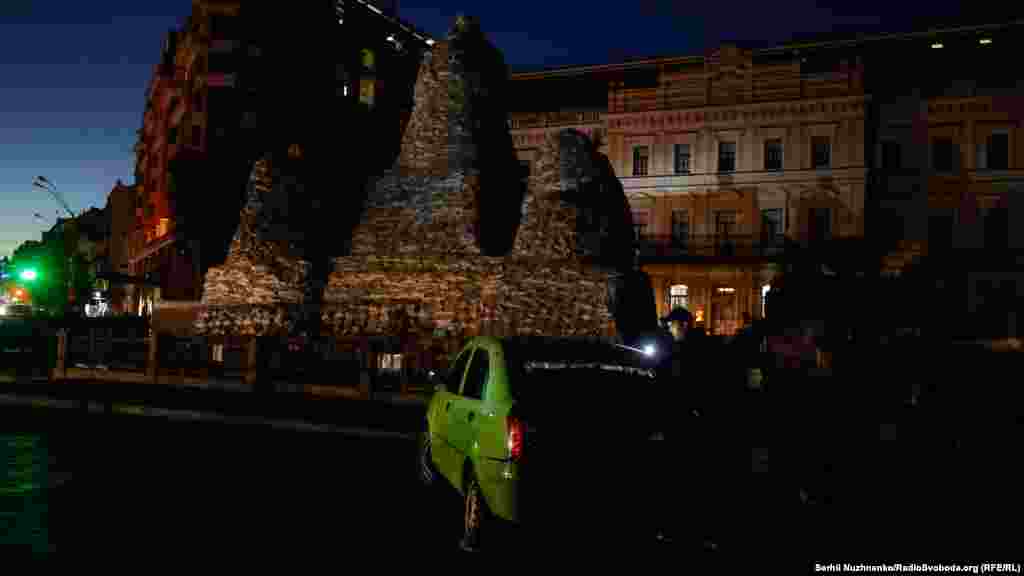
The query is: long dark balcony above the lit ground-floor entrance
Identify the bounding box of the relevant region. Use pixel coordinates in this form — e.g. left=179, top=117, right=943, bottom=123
left=636, top=235, right=786, bottom=262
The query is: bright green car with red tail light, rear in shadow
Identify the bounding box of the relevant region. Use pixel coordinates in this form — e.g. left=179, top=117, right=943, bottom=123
left=418, top=336, right=655, bottom=550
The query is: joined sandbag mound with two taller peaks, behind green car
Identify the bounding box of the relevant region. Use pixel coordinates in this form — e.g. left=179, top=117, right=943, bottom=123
left=323, top=15, right=630, bottom=337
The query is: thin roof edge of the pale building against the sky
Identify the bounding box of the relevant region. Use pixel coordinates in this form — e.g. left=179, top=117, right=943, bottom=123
left=511, top=19, right=1024, bottom=80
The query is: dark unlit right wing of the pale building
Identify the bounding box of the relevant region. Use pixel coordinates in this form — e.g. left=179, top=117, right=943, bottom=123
left=869, top=23, right=1024, bottom=266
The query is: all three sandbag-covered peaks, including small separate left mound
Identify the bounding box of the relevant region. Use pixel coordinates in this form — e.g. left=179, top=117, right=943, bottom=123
left=196, top=17, right=632, bottom=342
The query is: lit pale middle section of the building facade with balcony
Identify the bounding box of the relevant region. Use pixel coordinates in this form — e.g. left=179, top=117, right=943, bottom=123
left=512, top=45, right=867, bottom=334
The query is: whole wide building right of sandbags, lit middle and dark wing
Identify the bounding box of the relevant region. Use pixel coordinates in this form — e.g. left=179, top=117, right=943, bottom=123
left=510, top=22, right=1024, bottom=334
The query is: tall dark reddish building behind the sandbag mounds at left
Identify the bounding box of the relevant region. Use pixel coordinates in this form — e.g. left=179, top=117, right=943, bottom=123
left=129, top=0, right=432, bottom=317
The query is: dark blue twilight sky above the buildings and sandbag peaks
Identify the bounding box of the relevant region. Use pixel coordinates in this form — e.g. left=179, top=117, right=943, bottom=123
left=0, top=0, right=991, bottom=255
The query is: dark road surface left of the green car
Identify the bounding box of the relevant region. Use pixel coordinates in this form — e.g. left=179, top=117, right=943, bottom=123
left=0, top=399, right=444, bottom=558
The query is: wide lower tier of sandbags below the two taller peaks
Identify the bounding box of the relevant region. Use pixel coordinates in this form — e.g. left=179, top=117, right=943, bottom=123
left=324, top=255, right=614, bottom=336
